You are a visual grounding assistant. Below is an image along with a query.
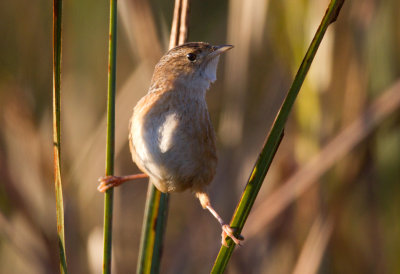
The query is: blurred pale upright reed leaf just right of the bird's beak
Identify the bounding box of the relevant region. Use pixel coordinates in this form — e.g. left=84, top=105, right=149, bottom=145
left=218, top=0, right=269, bottom=146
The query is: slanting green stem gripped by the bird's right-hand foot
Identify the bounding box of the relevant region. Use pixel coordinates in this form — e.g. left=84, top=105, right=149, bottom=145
left=211, top=0, right=344, bottom=273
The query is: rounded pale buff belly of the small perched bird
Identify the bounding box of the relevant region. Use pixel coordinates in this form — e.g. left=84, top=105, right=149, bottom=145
left=130, top=94, right=217, bottom=192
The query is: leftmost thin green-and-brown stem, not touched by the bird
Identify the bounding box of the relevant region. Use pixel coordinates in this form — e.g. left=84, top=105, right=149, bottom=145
left=53, top=0, right=67, bottom=273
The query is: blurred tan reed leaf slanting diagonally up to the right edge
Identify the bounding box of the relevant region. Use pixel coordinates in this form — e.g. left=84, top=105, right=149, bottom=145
left=243, top=81, right=400, bottom=238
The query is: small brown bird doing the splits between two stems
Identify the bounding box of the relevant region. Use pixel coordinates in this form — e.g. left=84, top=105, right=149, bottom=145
left=98, top=42, right=242, bottom=245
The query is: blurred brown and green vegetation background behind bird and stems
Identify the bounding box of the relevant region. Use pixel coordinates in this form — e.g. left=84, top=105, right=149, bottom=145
left=0, top=0, right=400, bottom=273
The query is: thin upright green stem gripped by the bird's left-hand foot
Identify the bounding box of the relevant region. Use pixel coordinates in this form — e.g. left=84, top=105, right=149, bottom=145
left=103, top=0, right=117, bottom=274
